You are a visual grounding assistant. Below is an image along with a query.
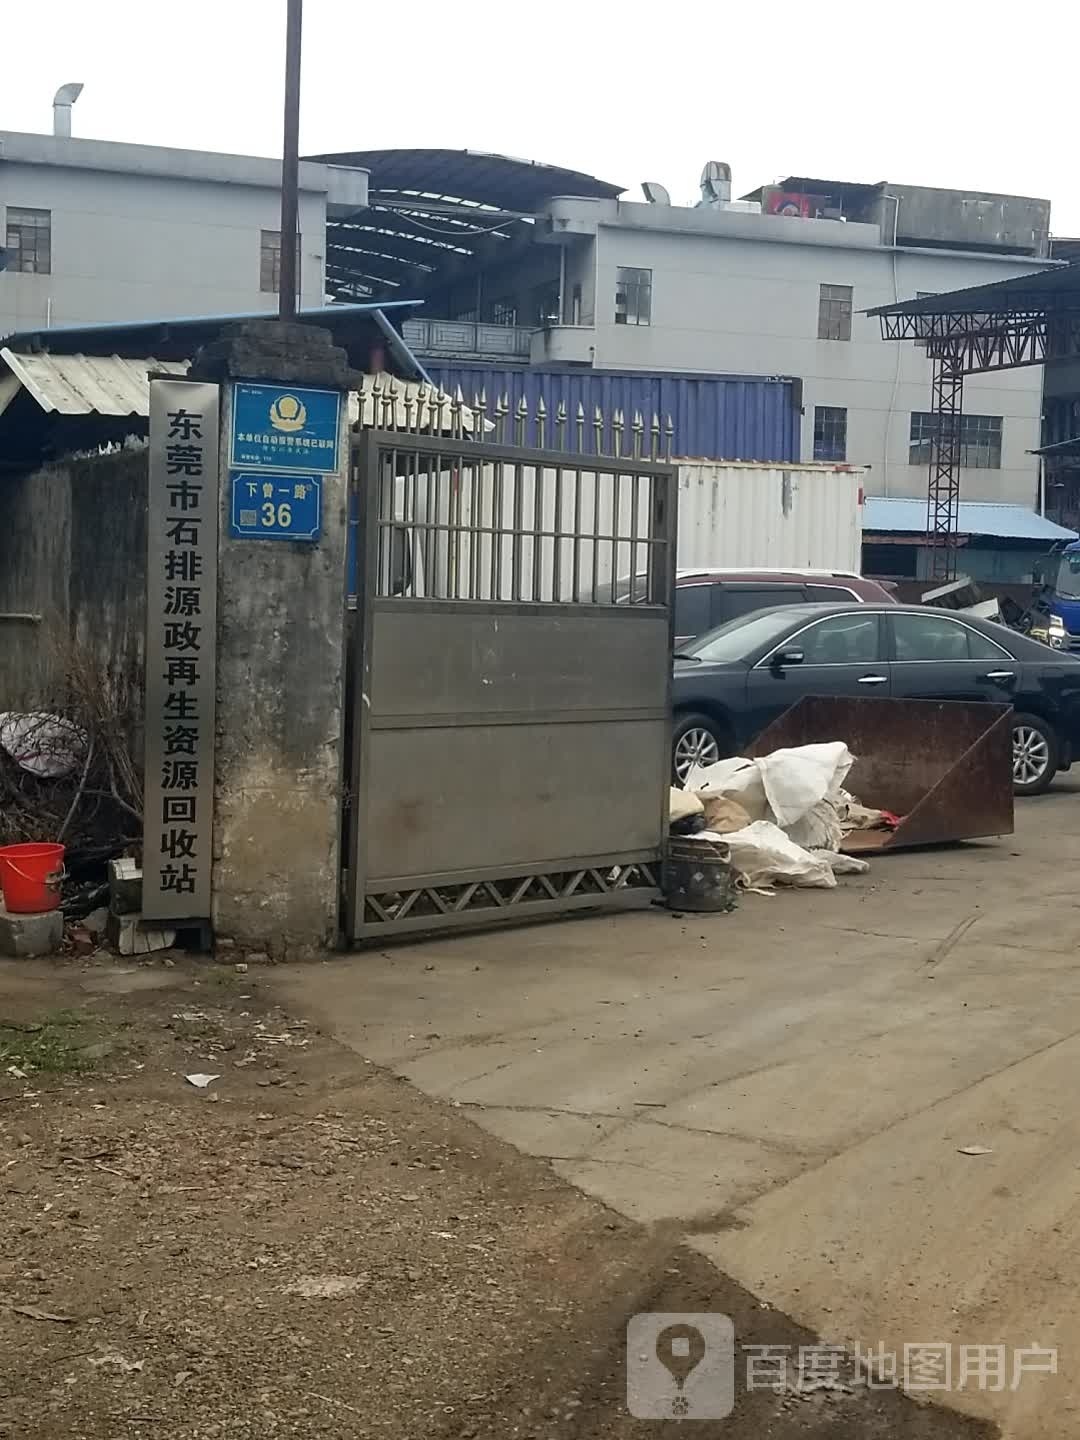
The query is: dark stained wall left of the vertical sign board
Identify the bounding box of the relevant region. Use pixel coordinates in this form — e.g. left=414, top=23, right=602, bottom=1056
left=0, top=451, right=147, bottom=708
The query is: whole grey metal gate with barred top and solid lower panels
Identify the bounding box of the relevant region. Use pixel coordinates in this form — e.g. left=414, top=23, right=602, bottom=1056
left=346, top=431, right=677, bottom=940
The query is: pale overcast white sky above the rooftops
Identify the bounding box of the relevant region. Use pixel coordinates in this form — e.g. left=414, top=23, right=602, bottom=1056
left=0, top=0, right=1080, bottom=235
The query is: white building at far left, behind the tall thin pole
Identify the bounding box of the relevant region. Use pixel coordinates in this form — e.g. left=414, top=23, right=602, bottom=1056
left=0, top=131, right=367, bottom=336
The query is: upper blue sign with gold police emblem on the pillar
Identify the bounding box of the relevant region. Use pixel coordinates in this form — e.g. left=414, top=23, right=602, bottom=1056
left=229, top=384, right=341, bottom=475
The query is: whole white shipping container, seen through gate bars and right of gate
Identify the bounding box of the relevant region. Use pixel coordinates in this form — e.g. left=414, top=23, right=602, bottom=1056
left=379, top=456, right=865, bottom=603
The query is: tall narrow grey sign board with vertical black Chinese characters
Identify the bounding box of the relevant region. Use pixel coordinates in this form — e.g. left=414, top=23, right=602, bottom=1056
left=143, top=380, right=219, bottom=920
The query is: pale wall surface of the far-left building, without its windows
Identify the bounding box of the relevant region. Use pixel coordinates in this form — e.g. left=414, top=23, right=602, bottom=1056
left=0, top=137, right=327, bottom=336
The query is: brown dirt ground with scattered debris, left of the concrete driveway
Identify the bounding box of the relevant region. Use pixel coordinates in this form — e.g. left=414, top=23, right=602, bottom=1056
left=0, top=959, right=991, bottom=1440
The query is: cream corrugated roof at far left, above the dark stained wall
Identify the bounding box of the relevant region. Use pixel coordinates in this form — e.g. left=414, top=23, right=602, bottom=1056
left=0, top=348, right=190, bottom=416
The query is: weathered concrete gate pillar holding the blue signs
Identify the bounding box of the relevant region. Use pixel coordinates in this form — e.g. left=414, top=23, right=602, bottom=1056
left=192, top=321, right=350, bottom=958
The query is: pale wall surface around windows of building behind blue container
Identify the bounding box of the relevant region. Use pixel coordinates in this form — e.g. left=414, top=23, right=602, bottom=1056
left=541, top=200, right=1044, bottom=505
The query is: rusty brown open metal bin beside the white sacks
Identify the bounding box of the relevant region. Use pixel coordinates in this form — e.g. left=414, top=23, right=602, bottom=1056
left=744, top=696, right=1014, bottom=855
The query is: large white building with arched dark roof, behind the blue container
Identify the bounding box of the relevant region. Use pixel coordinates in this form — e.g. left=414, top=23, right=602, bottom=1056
left=334, top=151, right=1051, bottom=507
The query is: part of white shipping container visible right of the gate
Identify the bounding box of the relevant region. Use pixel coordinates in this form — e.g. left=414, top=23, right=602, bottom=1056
left=678, top=461, right=865, bottom=573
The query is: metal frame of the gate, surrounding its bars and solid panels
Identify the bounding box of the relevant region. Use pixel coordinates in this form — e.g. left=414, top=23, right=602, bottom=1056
left=343, top=428, right=678, bottom=945
